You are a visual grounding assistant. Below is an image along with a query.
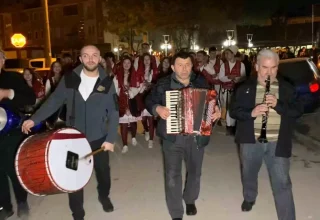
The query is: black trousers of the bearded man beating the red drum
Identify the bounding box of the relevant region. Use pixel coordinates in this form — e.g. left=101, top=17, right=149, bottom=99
left=69, top=138, right=111, bottom=219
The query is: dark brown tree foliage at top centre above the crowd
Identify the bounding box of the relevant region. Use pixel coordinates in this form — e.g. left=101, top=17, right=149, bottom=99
left=106, top=0, right=244, bottom=48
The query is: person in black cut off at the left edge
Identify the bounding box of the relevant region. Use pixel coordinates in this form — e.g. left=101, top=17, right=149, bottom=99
left=0, top=50, right=36, bottom=220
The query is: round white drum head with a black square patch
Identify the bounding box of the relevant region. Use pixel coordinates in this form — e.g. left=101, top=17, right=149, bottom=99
left=47, top=128, right=93, bottom=192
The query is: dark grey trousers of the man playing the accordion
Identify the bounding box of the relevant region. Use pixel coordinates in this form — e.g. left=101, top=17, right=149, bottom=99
left=162, top=135, right=204, bottom=218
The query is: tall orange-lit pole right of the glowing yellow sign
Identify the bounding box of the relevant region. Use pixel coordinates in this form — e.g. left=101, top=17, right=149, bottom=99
left=42, top=0, right=52, bottom=67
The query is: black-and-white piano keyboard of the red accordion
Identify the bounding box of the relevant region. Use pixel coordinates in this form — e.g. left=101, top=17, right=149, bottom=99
left=166, top=90, right=182, bottom=134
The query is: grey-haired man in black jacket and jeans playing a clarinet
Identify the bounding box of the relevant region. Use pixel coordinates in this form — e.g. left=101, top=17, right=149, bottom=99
left=230, top=49, right=303, bottom=220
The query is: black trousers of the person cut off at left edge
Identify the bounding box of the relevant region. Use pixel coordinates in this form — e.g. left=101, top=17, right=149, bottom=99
left=0, top=130, right=28, bottom=211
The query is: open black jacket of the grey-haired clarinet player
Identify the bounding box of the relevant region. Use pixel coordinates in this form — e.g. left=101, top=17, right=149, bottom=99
left=230, top=77, right=303, bottom=158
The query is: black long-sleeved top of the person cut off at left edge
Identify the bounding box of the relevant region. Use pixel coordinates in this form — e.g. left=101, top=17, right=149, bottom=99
left=0, top=70, right=36, bottom=113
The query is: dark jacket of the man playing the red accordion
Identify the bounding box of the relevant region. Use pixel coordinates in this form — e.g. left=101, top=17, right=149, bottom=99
left=146, top=73, right=210, bottom=147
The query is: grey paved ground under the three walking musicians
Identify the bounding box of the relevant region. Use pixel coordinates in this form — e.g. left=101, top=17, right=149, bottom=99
left=10, top=127, right=320, bottom=220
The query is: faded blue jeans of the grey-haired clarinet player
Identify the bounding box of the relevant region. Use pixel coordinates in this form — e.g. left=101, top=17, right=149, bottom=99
left=240, top=142, right=296, bottom=220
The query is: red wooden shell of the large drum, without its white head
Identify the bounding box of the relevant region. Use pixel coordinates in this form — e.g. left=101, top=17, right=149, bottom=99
left=15, top=128, right=93, bottom=196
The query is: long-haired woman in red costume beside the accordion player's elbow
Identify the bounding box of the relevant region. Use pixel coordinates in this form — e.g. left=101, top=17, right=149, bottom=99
left=137, top=53, right=158, bottom=148
